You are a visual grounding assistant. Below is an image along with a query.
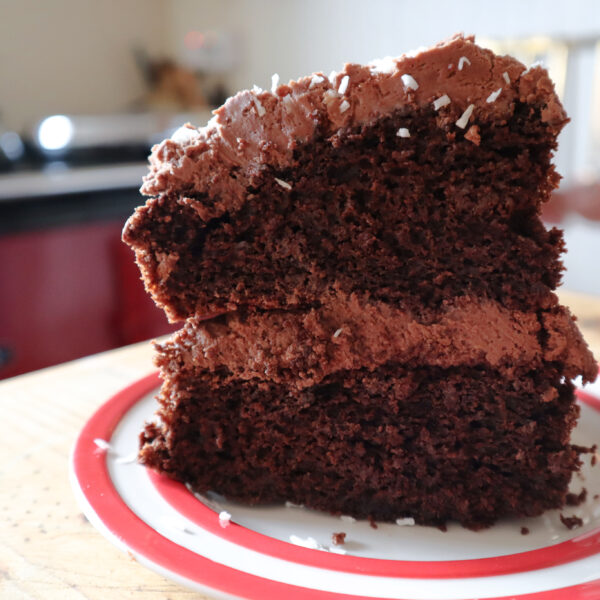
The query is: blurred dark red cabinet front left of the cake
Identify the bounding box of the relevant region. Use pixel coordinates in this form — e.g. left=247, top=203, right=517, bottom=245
left=0, top=219, right=174, bottom=378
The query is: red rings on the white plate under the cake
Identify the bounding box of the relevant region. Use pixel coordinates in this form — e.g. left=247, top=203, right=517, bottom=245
left=72, top=373, right=600, bottom=600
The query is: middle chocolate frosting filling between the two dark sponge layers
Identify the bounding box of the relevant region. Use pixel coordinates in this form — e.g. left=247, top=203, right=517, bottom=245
left=158, top=295, right=597, bottom=388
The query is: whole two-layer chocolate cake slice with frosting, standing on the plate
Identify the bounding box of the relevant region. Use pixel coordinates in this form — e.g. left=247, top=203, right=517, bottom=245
left=124, top=36, right=597, bottom=528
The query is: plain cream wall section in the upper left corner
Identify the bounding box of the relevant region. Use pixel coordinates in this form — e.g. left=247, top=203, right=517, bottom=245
left=0, top=0, right=170, bottom=130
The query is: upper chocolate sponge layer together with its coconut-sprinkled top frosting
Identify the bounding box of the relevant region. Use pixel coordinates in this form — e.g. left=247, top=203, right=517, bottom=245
left=124, top=38, right=566, bottom=320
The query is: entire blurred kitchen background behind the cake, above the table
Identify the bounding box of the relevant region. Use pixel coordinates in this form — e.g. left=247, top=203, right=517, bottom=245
left=0, top=0, right=600, bottom=378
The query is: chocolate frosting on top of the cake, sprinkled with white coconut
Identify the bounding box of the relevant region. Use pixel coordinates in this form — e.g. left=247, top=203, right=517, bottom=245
left=136, top=35, right=567, bottom=227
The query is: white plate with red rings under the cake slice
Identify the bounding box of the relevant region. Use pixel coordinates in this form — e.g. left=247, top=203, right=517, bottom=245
left=70, top=374, right=600, bottom=600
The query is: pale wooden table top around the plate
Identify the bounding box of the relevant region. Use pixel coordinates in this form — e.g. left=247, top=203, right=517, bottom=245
left=0, top=292, right=600, bottom=600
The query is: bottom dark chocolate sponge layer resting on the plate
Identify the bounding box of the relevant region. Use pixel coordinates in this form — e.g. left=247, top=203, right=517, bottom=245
left=140, top=363, right=579, bottom=529
